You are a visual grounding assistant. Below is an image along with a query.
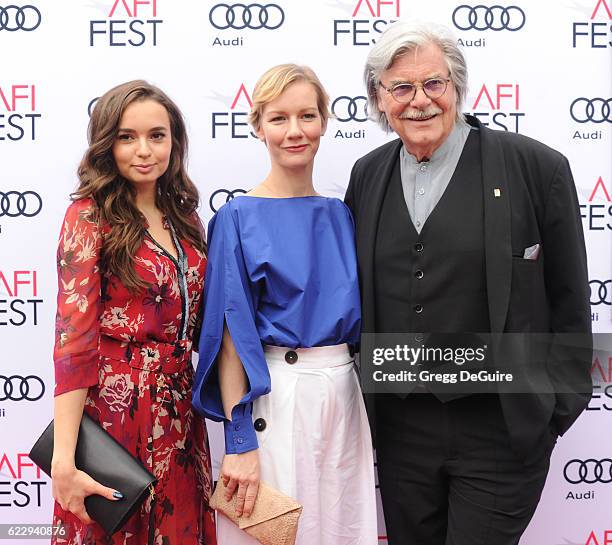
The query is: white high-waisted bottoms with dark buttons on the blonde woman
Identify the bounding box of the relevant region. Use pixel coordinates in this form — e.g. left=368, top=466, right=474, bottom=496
left=217, top=344, right=378, bottom=545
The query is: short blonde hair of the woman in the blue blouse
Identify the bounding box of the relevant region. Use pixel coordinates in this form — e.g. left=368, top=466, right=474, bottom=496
left=249, top=64, right=330, bottom=131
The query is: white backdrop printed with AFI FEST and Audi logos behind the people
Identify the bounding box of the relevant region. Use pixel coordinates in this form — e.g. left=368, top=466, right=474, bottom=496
left=0, top=0, right=612, bottom=545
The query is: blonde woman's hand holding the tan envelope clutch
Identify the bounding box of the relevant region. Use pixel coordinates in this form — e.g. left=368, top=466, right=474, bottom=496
left=220, top=449, right=259, bottom=517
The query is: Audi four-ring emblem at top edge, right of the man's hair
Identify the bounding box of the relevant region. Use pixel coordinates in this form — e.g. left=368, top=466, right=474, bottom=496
left=453, top=4, right=525, bottom=32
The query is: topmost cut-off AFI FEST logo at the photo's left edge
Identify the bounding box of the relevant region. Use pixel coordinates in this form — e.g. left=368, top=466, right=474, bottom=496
left=0, top=83, right=42, bottom=142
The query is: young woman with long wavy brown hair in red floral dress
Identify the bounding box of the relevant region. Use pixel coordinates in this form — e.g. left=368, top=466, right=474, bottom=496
left=52, top=81, right=216, bottom=545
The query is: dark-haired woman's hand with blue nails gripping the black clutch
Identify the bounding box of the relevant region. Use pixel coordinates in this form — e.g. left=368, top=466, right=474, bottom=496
left=51, top=460, right=123, bottom=524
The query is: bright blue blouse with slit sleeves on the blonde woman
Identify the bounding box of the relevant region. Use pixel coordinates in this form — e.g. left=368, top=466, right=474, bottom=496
left=193, top=196, right=361, bottom=453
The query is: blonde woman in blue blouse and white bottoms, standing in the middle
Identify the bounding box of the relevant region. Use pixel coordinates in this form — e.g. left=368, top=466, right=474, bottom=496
left=194, top=65, right=378, bottom=545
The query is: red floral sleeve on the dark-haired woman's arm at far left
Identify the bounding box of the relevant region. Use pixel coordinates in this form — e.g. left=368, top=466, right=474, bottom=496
left=53, top=199, right=102, bottom=396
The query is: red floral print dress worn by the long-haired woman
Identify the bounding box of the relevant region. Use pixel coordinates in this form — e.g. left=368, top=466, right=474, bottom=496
left=52, top=199, right=216, bottom=545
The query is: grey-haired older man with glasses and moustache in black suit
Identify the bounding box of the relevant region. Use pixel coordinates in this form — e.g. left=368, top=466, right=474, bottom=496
left=346, top=23, right=591, bottom=545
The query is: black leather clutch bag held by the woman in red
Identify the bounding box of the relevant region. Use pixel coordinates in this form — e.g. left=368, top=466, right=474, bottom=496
left=30, top=413, right=157, bottom=535
